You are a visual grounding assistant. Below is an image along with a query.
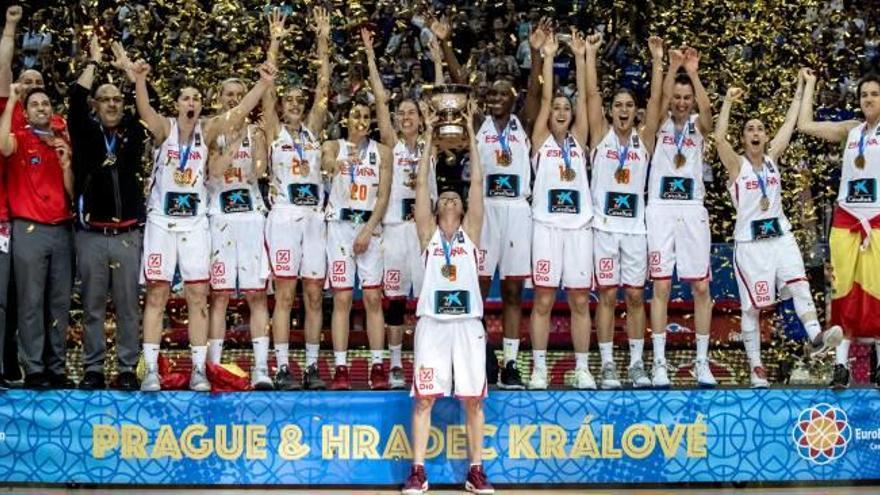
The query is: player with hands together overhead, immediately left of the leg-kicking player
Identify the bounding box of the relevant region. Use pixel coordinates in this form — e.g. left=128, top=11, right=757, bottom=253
left=645, top=48, right=716, bottom=388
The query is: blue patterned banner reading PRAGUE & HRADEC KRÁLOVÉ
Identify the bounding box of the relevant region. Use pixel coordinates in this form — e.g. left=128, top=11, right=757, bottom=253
left=0, top=389, right=880, bottom=485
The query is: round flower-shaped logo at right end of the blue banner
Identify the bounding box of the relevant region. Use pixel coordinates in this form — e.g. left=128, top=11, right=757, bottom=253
left=791, top=403, right=852, bottom=464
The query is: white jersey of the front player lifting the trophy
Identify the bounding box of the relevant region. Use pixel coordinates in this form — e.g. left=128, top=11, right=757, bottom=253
left=416, top=227, right=483, bottom=320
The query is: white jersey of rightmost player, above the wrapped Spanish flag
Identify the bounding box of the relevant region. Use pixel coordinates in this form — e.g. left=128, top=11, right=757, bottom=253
left=837, top=123, right=880, bottom=217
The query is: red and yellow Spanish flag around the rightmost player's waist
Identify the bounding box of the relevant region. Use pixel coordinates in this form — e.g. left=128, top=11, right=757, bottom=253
left=828, top=205, right=880, bottom=338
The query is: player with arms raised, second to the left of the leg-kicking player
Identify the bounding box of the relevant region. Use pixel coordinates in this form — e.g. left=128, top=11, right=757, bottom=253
left=586, top=34, right=663, bottom=389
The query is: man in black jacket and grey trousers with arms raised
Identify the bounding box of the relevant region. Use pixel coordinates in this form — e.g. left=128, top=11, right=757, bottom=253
left=68, top=36, right=148, bottom=390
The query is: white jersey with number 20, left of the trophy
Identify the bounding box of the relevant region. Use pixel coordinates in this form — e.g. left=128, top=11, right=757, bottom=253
left=327, top=139, right=382, bottom=222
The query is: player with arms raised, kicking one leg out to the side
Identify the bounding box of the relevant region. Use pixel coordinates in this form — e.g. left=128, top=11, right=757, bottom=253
left=715, top=71, right=843, bottom=388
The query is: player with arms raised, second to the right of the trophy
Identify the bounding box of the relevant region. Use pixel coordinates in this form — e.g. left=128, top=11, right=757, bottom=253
left=529, top=29, right=596, bottom=389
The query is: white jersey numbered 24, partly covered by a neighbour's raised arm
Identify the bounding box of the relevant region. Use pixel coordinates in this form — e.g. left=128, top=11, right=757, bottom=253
left=206, top=125, right=266, bottom=215
